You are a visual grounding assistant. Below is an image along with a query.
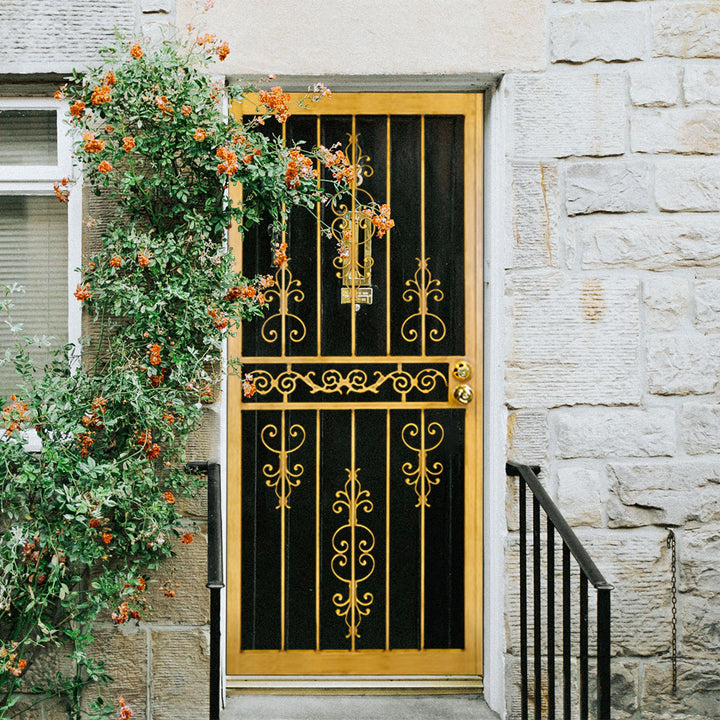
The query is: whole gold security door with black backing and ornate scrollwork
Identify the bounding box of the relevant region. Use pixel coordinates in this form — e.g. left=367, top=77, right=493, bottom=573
left=227, top=93, right=482, bottom=675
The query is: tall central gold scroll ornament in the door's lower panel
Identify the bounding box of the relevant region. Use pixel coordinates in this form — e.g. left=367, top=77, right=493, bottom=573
left=330, top=468, right=375, bottom=649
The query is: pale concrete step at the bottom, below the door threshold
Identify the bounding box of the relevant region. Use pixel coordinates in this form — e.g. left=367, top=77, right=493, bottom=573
left=220, top=694, right=500, bottom=720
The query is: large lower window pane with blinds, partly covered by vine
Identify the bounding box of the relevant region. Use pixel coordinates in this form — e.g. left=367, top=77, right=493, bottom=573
left=0, top=196, right=68, bottom=398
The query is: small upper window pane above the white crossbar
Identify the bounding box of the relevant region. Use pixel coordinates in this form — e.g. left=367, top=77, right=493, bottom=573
left=0, top=110, right=58, bottom=165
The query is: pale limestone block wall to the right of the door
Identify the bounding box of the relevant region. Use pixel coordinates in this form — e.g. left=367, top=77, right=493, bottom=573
left=504, top=0, right=720, bottom=720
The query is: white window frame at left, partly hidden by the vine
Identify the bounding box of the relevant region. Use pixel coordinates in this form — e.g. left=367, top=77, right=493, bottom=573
left=0, top=97, right=82, bottom=451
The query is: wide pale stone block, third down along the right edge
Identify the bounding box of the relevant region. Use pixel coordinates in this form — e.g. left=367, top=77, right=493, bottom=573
left=630, top=108, right=720, bottom=155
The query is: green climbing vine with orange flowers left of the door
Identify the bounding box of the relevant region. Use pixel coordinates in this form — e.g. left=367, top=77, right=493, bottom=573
left=0, top=25, right=392, bottom=719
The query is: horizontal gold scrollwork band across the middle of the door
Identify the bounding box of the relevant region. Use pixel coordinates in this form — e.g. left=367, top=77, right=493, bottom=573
left=250, top=368, right=447, bottom=395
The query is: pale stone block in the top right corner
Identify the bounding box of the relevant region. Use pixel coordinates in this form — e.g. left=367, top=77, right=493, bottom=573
left=653, top=2, right=720, bottom=58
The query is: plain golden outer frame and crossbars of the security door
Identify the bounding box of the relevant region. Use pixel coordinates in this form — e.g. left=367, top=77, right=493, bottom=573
left=226, top=93, right=483, bottom=676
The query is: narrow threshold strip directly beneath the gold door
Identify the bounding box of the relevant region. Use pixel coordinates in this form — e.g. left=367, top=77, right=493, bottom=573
left=225, top=675, right=483, bottom=695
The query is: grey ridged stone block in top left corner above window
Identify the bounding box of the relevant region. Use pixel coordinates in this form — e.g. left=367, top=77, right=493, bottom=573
left=0, top=0, right=136, bottom=74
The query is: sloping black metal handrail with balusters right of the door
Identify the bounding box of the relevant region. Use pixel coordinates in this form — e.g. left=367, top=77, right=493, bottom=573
left=505, top=462, right=613, bottom=720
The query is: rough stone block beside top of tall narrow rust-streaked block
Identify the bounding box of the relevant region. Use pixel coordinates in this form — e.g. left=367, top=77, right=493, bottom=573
left=565, top=161, right=650, bottom=215
